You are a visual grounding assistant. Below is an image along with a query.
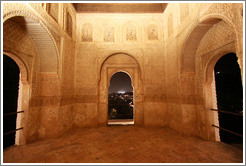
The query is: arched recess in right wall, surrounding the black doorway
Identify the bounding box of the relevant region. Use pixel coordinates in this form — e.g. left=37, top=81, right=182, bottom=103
left=180, top=14, right=240, bottom=141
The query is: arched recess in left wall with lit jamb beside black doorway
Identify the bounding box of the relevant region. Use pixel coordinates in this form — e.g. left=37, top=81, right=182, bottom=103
left=3, top=14, right=60, bottom=145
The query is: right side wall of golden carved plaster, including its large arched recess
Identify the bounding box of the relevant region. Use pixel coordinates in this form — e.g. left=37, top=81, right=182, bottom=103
left=164, top=3, right=243, bottom=140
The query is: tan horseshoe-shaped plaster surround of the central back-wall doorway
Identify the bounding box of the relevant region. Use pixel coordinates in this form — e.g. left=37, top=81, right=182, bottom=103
left=98, top=53, right=143, bottom=126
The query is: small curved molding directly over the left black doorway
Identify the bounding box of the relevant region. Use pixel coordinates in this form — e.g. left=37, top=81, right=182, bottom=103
left=3, top=51, right=31, bottom=84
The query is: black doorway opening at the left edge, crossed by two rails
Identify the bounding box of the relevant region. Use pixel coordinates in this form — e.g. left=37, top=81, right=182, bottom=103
left=3, top=55, right=20, bottom=148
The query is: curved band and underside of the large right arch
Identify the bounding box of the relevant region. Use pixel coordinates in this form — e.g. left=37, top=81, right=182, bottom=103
left=180, top=13, right=238, bottom=74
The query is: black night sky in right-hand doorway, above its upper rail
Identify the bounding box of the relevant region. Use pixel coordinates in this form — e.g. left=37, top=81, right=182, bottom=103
left=214, top=53, right=243, bottom=111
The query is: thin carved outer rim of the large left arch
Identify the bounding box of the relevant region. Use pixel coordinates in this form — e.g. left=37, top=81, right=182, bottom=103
left=3, top=10, right=61, bottom=75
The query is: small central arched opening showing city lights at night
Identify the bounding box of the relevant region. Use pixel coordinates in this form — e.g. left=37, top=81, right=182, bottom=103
left=108, top=72, right=134, bottom=125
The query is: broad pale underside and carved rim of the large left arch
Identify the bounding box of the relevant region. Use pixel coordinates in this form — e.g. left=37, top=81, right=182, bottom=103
left=3, top=10, right=59, bottom=75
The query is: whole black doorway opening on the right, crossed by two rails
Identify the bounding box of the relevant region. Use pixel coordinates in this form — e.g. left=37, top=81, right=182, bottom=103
left=214, top=53, right=243, bottom=144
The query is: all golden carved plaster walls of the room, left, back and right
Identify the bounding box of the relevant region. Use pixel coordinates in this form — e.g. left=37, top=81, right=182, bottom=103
left=3, top=3, right=243, bottom=144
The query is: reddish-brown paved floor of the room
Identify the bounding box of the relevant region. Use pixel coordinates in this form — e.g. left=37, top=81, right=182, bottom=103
left=3, top=126, right=243, bottom=163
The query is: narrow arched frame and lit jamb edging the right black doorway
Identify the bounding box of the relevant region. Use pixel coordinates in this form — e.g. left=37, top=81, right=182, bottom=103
left=203, top=48, right=242, bottom=141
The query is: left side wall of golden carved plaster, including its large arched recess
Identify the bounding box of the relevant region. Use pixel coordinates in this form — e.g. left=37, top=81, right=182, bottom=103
left=3, top=3, right=75, bottom=143
